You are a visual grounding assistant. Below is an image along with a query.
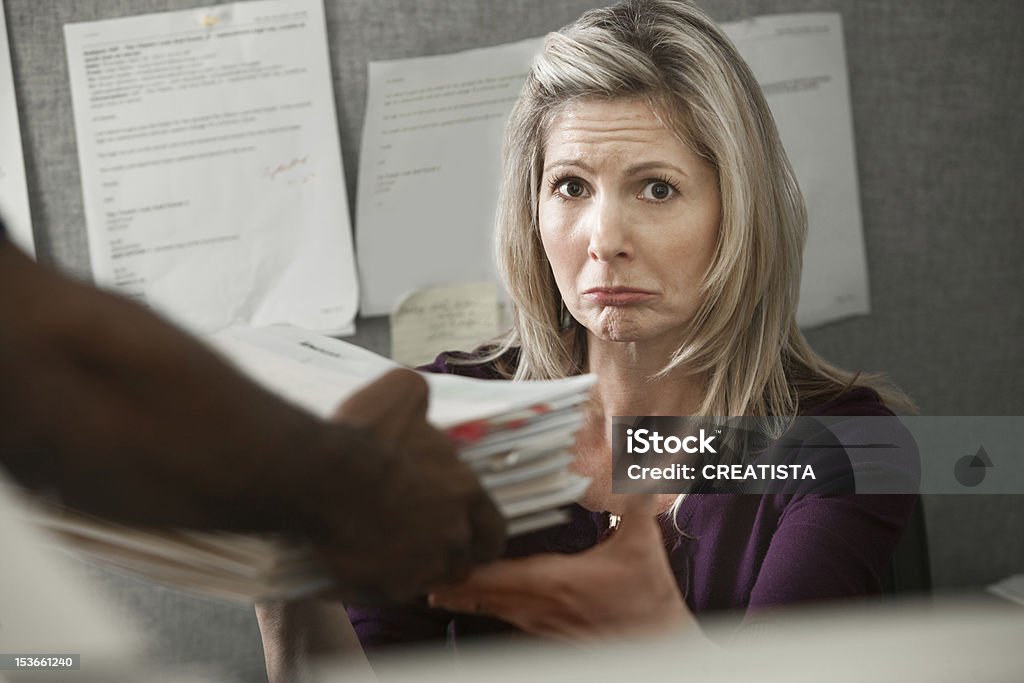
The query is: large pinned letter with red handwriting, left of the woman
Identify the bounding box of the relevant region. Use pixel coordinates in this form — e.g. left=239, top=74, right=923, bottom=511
left=65, top=0, right=358, bottom=332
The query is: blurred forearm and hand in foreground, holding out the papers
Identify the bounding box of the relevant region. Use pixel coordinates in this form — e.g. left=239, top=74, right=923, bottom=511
left=0, top=244, right=504, bottom=601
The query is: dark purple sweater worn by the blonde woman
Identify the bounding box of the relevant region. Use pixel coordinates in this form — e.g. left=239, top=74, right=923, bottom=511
left=348, top=354, right=914, bottom=651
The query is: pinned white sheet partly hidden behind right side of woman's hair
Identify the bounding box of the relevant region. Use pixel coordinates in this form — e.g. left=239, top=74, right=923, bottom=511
left=722, top=13, right=870, bottom=327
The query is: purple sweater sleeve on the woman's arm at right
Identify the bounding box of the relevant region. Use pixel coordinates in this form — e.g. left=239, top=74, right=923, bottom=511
left=748, top=395, right=920, bottom=616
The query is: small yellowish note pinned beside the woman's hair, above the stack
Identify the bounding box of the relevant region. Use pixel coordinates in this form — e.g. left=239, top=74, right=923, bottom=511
left=391, top=282, right=498, bottom=368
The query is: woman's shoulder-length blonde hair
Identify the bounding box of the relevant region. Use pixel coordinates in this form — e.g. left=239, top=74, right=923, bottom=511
left=473, top=0, right=912, bottom=416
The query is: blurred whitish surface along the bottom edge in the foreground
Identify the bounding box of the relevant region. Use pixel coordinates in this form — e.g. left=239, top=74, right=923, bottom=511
left=312, top=599, right=1024, bottom=683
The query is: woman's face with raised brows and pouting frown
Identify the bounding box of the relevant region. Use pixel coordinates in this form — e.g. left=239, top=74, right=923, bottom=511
left=539, top=99, right=721, bottom=343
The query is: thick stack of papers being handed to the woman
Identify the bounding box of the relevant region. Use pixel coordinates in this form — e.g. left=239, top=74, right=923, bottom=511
left=22, top=328, right=594, bottom=601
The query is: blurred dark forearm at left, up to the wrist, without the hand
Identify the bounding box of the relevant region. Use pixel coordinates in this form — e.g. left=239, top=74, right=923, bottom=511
left=0, top=241, right=331, bottom=531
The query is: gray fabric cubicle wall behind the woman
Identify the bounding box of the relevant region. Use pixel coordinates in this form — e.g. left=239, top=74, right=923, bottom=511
left=5, top=0, right=1024, bottom=680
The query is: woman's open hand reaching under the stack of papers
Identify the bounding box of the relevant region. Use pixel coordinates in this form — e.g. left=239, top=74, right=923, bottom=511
left=429, top=496, right=697, bottom=641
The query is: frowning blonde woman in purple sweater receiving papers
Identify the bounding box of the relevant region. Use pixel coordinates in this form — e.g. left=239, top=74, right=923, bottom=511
left=260, top=0, right=913, bottom=667
